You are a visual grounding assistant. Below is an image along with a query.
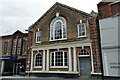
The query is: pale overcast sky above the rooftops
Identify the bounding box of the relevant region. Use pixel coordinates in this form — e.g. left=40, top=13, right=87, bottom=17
left=0, top=0, right=101, bottom=36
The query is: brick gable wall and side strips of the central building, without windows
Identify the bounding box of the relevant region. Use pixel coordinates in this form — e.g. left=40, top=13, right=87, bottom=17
left=26, top=2, right=101, bottom=73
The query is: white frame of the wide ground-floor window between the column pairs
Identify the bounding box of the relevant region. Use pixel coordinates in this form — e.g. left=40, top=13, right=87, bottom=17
left=50, top=51, right=68, bottom=68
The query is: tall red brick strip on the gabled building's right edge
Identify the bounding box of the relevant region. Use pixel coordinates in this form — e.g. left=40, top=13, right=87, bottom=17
left=90, top=19, right=101, bottom=73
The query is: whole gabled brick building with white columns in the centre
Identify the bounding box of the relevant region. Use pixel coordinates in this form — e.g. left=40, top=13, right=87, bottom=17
left=26, top=2, right=102, bottom=77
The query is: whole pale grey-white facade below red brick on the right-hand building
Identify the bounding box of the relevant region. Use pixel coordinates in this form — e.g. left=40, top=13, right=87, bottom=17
left=99, top=16, right=120, bottom=77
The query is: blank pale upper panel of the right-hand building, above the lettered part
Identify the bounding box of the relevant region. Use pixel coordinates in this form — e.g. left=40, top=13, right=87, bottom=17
left=99, top=16, right=120, bottom=47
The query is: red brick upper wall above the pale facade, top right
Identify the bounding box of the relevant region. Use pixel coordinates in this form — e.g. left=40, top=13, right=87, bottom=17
left=97, top=2, right=120, bottom=19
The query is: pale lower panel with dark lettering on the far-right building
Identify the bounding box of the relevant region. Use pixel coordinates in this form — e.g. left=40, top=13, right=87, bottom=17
left=103, top=51, right=120, bottom=77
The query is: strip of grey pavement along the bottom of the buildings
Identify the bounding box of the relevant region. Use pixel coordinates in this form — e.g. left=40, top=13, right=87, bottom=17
left=0, top=76, right=120, bottom=80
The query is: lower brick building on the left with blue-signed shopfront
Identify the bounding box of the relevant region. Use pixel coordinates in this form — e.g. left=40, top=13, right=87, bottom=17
left=0, top=30, right=28, bottom=75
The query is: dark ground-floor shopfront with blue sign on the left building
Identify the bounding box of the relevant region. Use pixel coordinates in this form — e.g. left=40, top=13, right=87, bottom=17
left=0, top=56, right=26, bottom=75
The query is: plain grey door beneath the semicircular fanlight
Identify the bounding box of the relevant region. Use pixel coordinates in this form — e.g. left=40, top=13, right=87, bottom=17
left=79, top=57, right=91, bottom=76
